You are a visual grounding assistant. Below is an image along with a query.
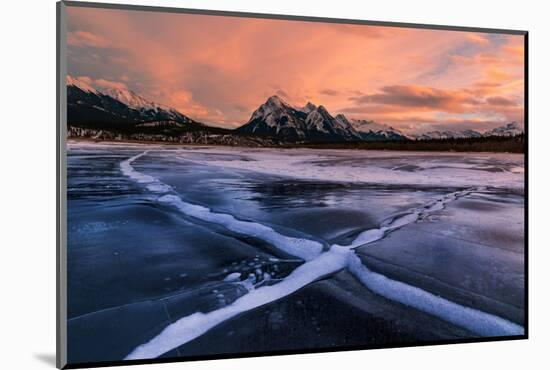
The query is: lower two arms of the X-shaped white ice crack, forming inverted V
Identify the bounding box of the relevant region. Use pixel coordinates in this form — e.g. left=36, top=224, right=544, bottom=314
left=125, top=233, right=524, bottom=360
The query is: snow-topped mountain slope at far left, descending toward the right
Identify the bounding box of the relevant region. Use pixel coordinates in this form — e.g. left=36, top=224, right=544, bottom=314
left=67, top=76, right=202, bottom=128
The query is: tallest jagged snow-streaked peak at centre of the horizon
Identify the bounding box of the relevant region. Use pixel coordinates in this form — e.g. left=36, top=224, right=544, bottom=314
left=237, top=95, right=361, bottom=142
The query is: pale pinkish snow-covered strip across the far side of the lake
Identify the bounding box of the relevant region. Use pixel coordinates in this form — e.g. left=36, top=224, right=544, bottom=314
left=174, top=148, right=524, bottom=188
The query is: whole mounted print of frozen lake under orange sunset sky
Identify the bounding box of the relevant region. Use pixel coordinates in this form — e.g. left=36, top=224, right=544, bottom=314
left=57, top=2, right=527, bottom=368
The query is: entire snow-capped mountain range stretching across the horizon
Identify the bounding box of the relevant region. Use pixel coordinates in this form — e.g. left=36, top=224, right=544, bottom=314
left=67, top=76, right=523, bottom=145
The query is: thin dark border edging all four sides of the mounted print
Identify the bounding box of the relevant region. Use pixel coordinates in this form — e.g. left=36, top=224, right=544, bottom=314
left=56, top=1, right=529, bottom=369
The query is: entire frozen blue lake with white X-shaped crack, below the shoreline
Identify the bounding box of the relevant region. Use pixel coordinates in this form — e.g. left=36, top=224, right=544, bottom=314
left=68, top=143, right=525, bottom=363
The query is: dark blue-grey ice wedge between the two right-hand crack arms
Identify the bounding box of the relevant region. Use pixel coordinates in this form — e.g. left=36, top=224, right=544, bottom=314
left=357, top=189, right=525, bottom=324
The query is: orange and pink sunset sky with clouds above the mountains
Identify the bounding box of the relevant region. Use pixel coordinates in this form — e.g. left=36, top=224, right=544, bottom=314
left=67, top=7, right=524, bottom=133
